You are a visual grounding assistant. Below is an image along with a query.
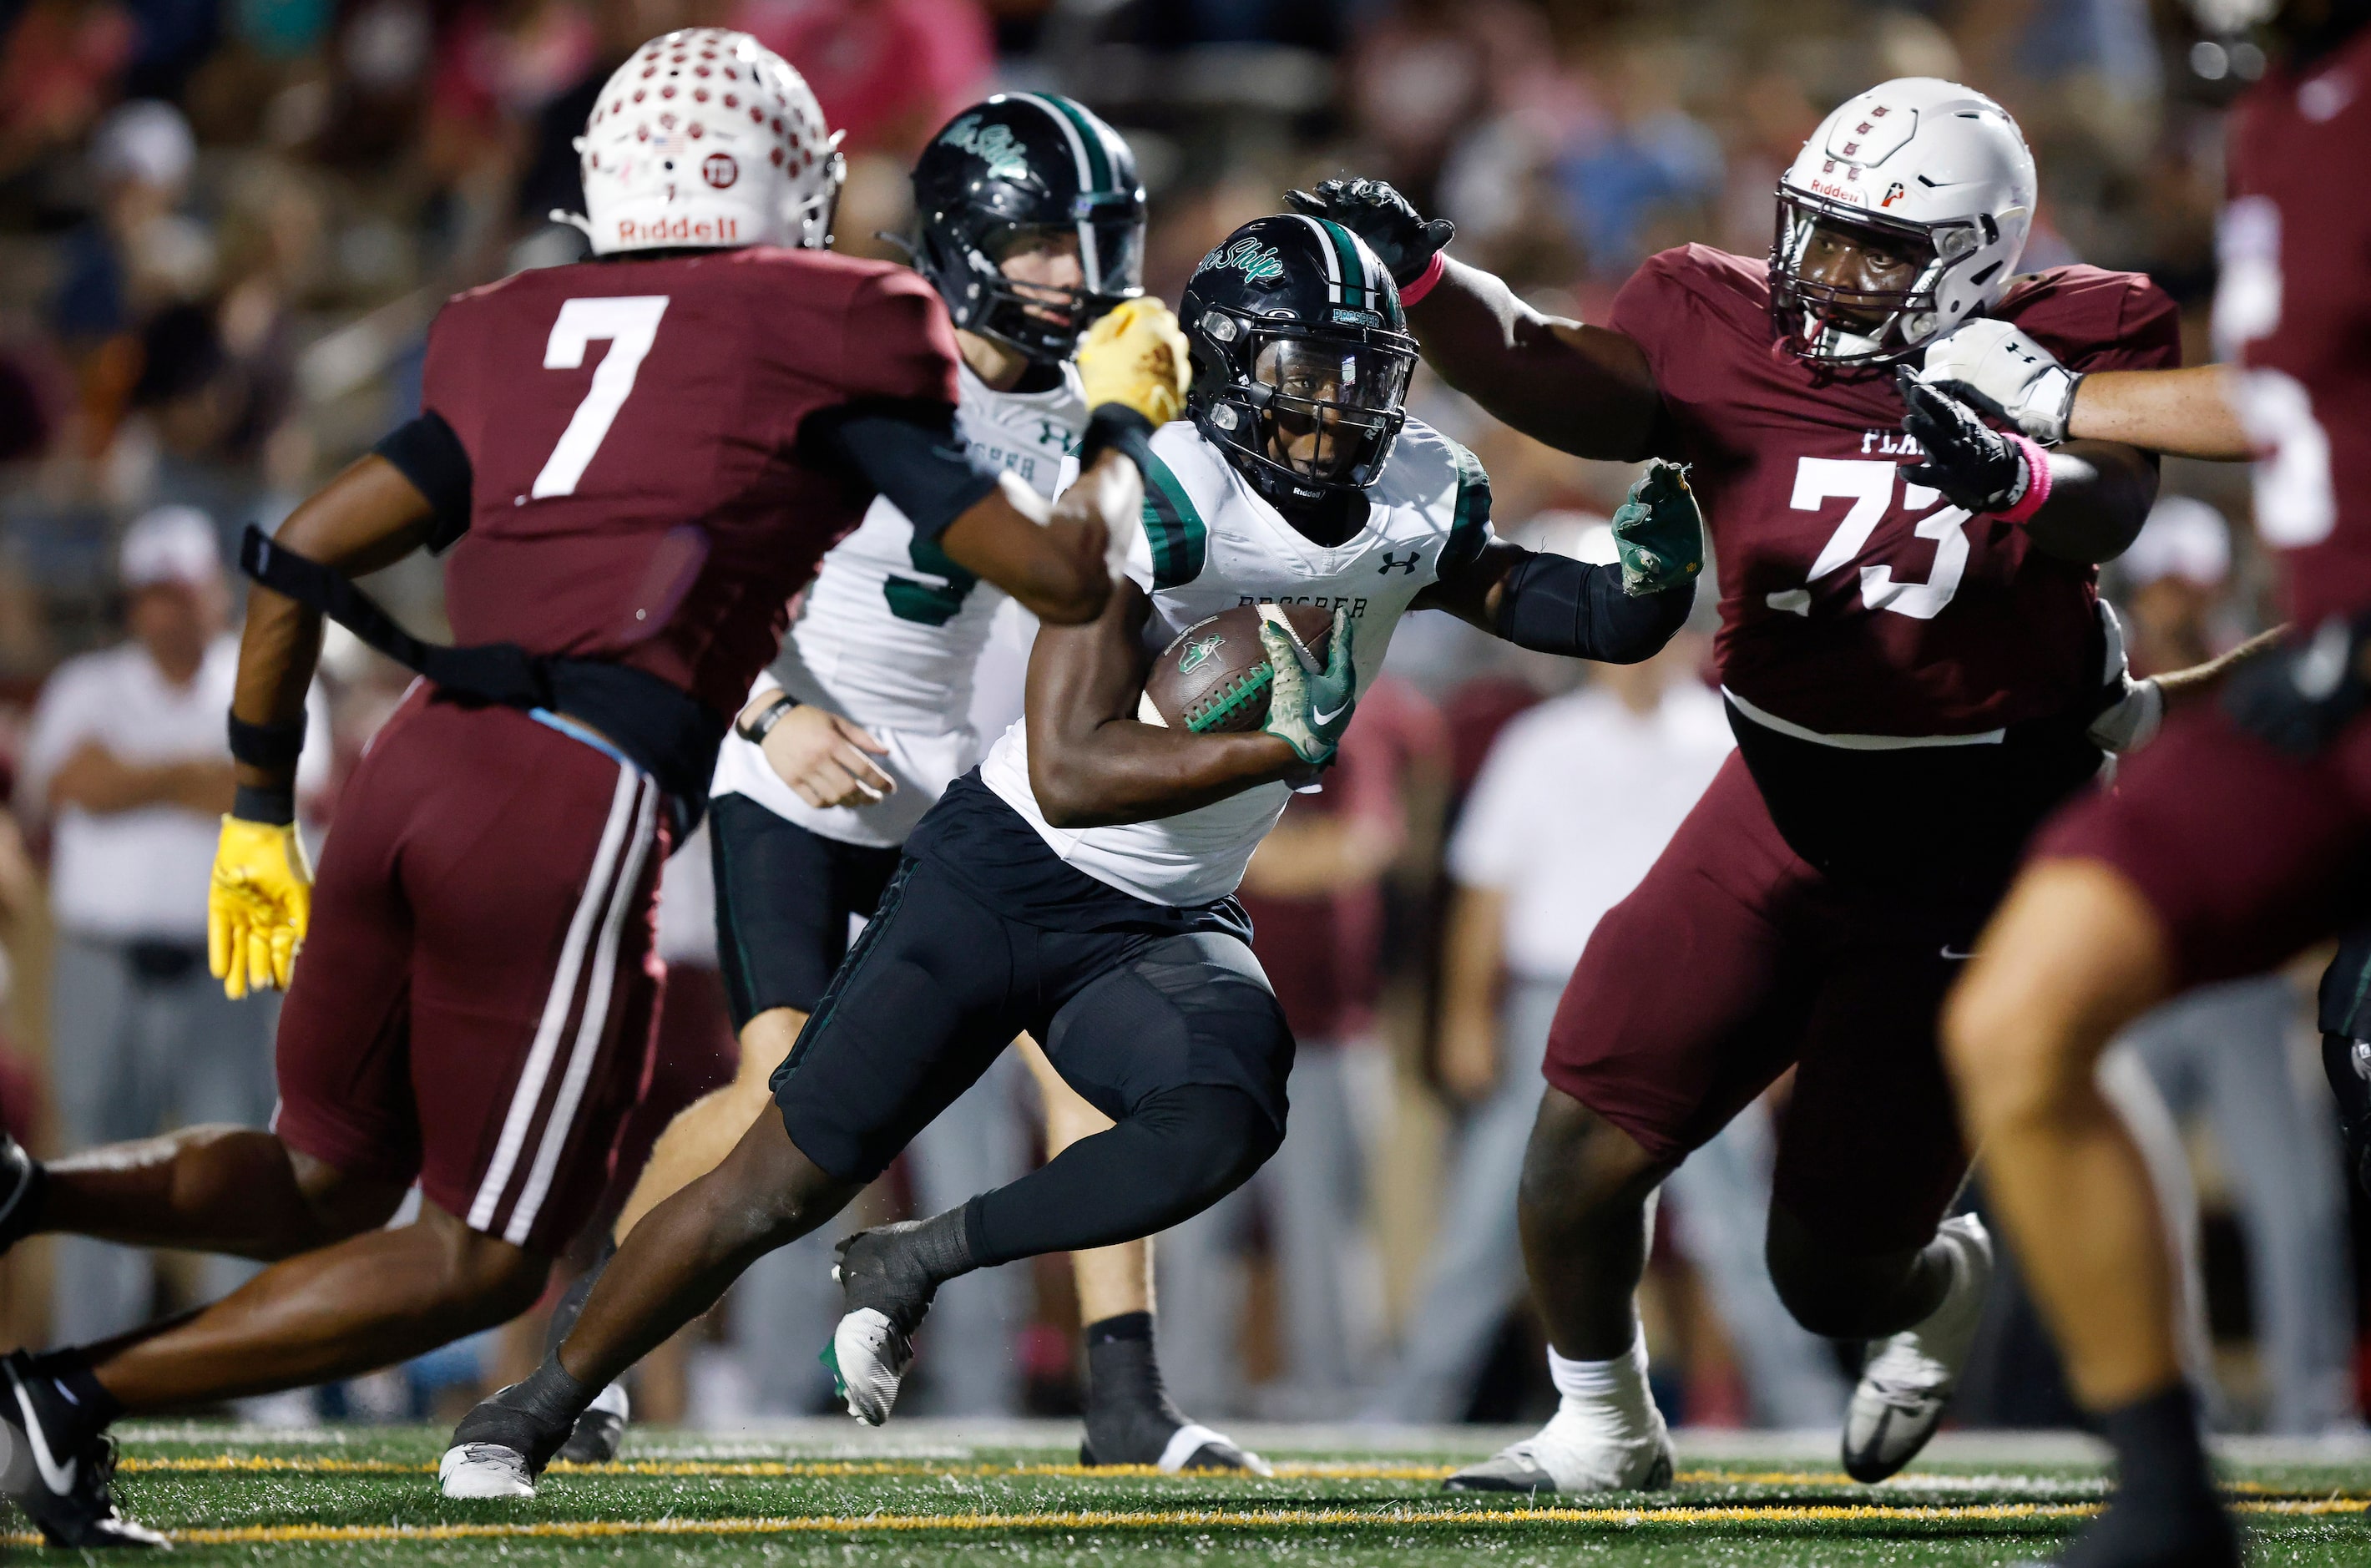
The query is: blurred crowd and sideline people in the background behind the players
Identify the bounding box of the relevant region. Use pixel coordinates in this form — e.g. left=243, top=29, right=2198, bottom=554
left=0, top=0, right=2366, bottom=1433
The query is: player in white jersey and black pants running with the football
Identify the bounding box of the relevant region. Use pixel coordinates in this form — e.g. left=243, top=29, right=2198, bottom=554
left=443, top=216, right=1702, bottom=1495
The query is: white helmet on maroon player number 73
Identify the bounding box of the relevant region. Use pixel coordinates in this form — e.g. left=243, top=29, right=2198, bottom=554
left=1771, top=76, right=2035, bottom=366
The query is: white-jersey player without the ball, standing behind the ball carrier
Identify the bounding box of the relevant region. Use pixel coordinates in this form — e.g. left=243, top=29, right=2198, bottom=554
left=535, top=93, right=1266, bottom=1471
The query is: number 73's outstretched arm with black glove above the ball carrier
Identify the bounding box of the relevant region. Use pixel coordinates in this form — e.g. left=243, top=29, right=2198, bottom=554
left=1285, top=180, right=1660, bottom=463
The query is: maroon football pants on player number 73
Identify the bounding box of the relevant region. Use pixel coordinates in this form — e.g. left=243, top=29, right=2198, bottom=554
left=1546, top=754, right=1989, bottom=1255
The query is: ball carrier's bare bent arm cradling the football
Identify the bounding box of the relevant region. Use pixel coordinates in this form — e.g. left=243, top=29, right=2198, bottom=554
left=1027, top=581, right=1312, bottom=828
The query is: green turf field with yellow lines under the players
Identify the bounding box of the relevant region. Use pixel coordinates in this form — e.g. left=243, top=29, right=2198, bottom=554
left=12, top=1426, right=2371, bottom=1568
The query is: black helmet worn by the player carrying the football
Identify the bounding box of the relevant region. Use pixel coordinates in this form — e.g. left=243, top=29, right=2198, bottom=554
left=1178, top=216, right=1415, bottom=505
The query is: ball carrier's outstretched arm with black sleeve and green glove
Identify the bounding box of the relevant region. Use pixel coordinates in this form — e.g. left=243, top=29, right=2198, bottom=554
left=1415, top=463, right=1705, bottom=665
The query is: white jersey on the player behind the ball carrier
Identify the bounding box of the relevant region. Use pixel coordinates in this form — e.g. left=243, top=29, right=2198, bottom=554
left=711, top=363, right=1086, bottom=844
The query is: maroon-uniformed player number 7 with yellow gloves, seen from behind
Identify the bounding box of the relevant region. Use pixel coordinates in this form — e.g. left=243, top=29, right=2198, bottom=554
left=0, top=28, right=1186, bottom=1545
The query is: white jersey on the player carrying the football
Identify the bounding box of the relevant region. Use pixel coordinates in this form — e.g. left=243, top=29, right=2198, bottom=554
left=979, top=420, right=1491, bottom=906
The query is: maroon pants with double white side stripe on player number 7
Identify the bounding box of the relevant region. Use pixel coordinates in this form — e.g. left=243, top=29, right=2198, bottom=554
left=273, top=683, right=669, bottom=1252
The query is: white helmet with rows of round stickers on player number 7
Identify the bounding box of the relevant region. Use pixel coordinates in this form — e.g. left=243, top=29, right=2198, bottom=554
left=566, top=26, right=849, bottom=256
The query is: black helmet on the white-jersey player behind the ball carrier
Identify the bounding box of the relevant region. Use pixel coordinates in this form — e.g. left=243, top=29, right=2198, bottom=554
left=911, top=93, right=1145, bottom=363
